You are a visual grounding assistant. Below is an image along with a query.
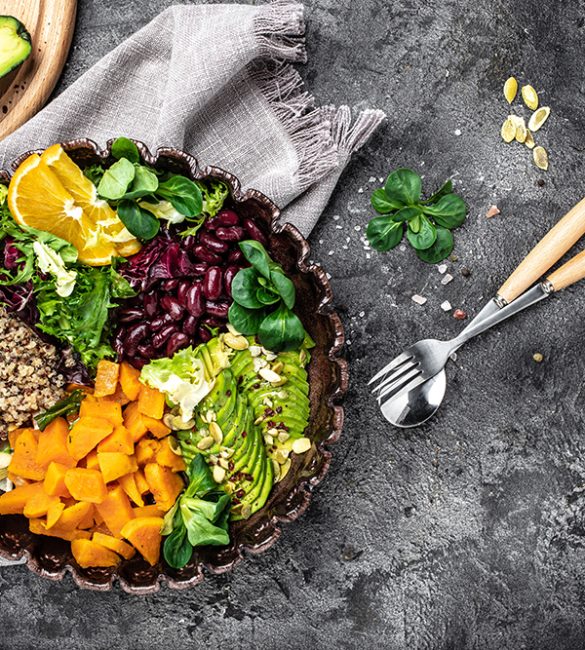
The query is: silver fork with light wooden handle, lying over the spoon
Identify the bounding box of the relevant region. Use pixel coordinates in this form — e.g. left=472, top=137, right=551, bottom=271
left=368, top=199, right=585, bottom=403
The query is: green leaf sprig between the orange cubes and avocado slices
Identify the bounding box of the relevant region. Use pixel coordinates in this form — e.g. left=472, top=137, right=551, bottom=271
left=162, top=454, right=231, bottom=569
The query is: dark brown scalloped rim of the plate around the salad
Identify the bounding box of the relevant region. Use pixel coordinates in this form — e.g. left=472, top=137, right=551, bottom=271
left=0, top=139, right=348, bottom=594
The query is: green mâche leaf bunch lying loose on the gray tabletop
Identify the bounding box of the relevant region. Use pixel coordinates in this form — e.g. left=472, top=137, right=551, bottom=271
left=366, top=168, right=467, bottom=264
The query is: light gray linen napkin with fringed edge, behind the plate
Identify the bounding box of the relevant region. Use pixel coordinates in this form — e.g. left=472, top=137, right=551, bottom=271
left=0, top=0, right=385, bottom=564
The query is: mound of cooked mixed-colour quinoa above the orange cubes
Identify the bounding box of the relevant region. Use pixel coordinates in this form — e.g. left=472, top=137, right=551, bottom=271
left=0, top=308, right=65, bottom=437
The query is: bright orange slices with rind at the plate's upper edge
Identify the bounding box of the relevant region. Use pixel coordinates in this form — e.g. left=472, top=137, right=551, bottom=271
left=8, top=144, right=141, bottom=266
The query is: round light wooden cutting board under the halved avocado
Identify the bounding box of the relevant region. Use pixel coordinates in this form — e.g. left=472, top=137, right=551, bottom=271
left=0, top=0, right=77, bottom=140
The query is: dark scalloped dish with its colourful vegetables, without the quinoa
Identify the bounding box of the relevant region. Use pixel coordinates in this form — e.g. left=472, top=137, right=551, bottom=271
left=0, top=138, right=348, bottom=593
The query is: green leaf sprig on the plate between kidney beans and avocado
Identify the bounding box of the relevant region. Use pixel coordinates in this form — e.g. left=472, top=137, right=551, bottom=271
left=228, top=240, right=307, bottom=352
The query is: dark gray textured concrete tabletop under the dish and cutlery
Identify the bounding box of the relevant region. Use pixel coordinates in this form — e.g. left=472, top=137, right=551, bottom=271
left=0, top=0, right=585, bottom=650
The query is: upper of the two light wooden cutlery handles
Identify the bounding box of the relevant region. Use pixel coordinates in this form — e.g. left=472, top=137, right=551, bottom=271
left=498, top=194, right=585, bottom=302
